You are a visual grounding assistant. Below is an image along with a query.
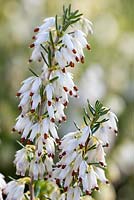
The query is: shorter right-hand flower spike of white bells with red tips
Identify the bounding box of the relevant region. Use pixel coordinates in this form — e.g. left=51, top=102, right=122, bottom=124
left=53, top=104, right=117, bottom=200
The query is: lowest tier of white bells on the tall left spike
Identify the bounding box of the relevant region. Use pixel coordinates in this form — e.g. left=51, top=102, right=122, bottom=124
left=14, top=142, right=53, bottom=180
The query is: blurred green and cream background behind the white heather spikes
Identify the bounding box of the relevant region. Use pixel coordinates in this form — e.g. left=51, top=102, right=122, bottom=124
left=0, top=0, right=134, bottom=200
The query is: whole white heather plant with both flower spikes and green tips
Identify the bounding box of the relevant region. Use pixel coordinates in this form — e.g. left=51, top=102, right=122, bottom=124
left=0, top=5, right=117, bottom=200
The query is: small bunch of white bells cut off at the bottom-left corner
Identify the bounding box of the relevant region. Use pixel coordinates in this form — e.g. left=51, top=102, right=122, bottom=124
left=4, top=180, right=25, bottom=200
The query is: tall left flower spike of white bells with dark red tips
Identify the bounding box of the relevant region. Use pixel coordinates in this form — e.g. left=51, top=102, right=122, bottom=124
left=13, top=5, right=92, bottom=179
